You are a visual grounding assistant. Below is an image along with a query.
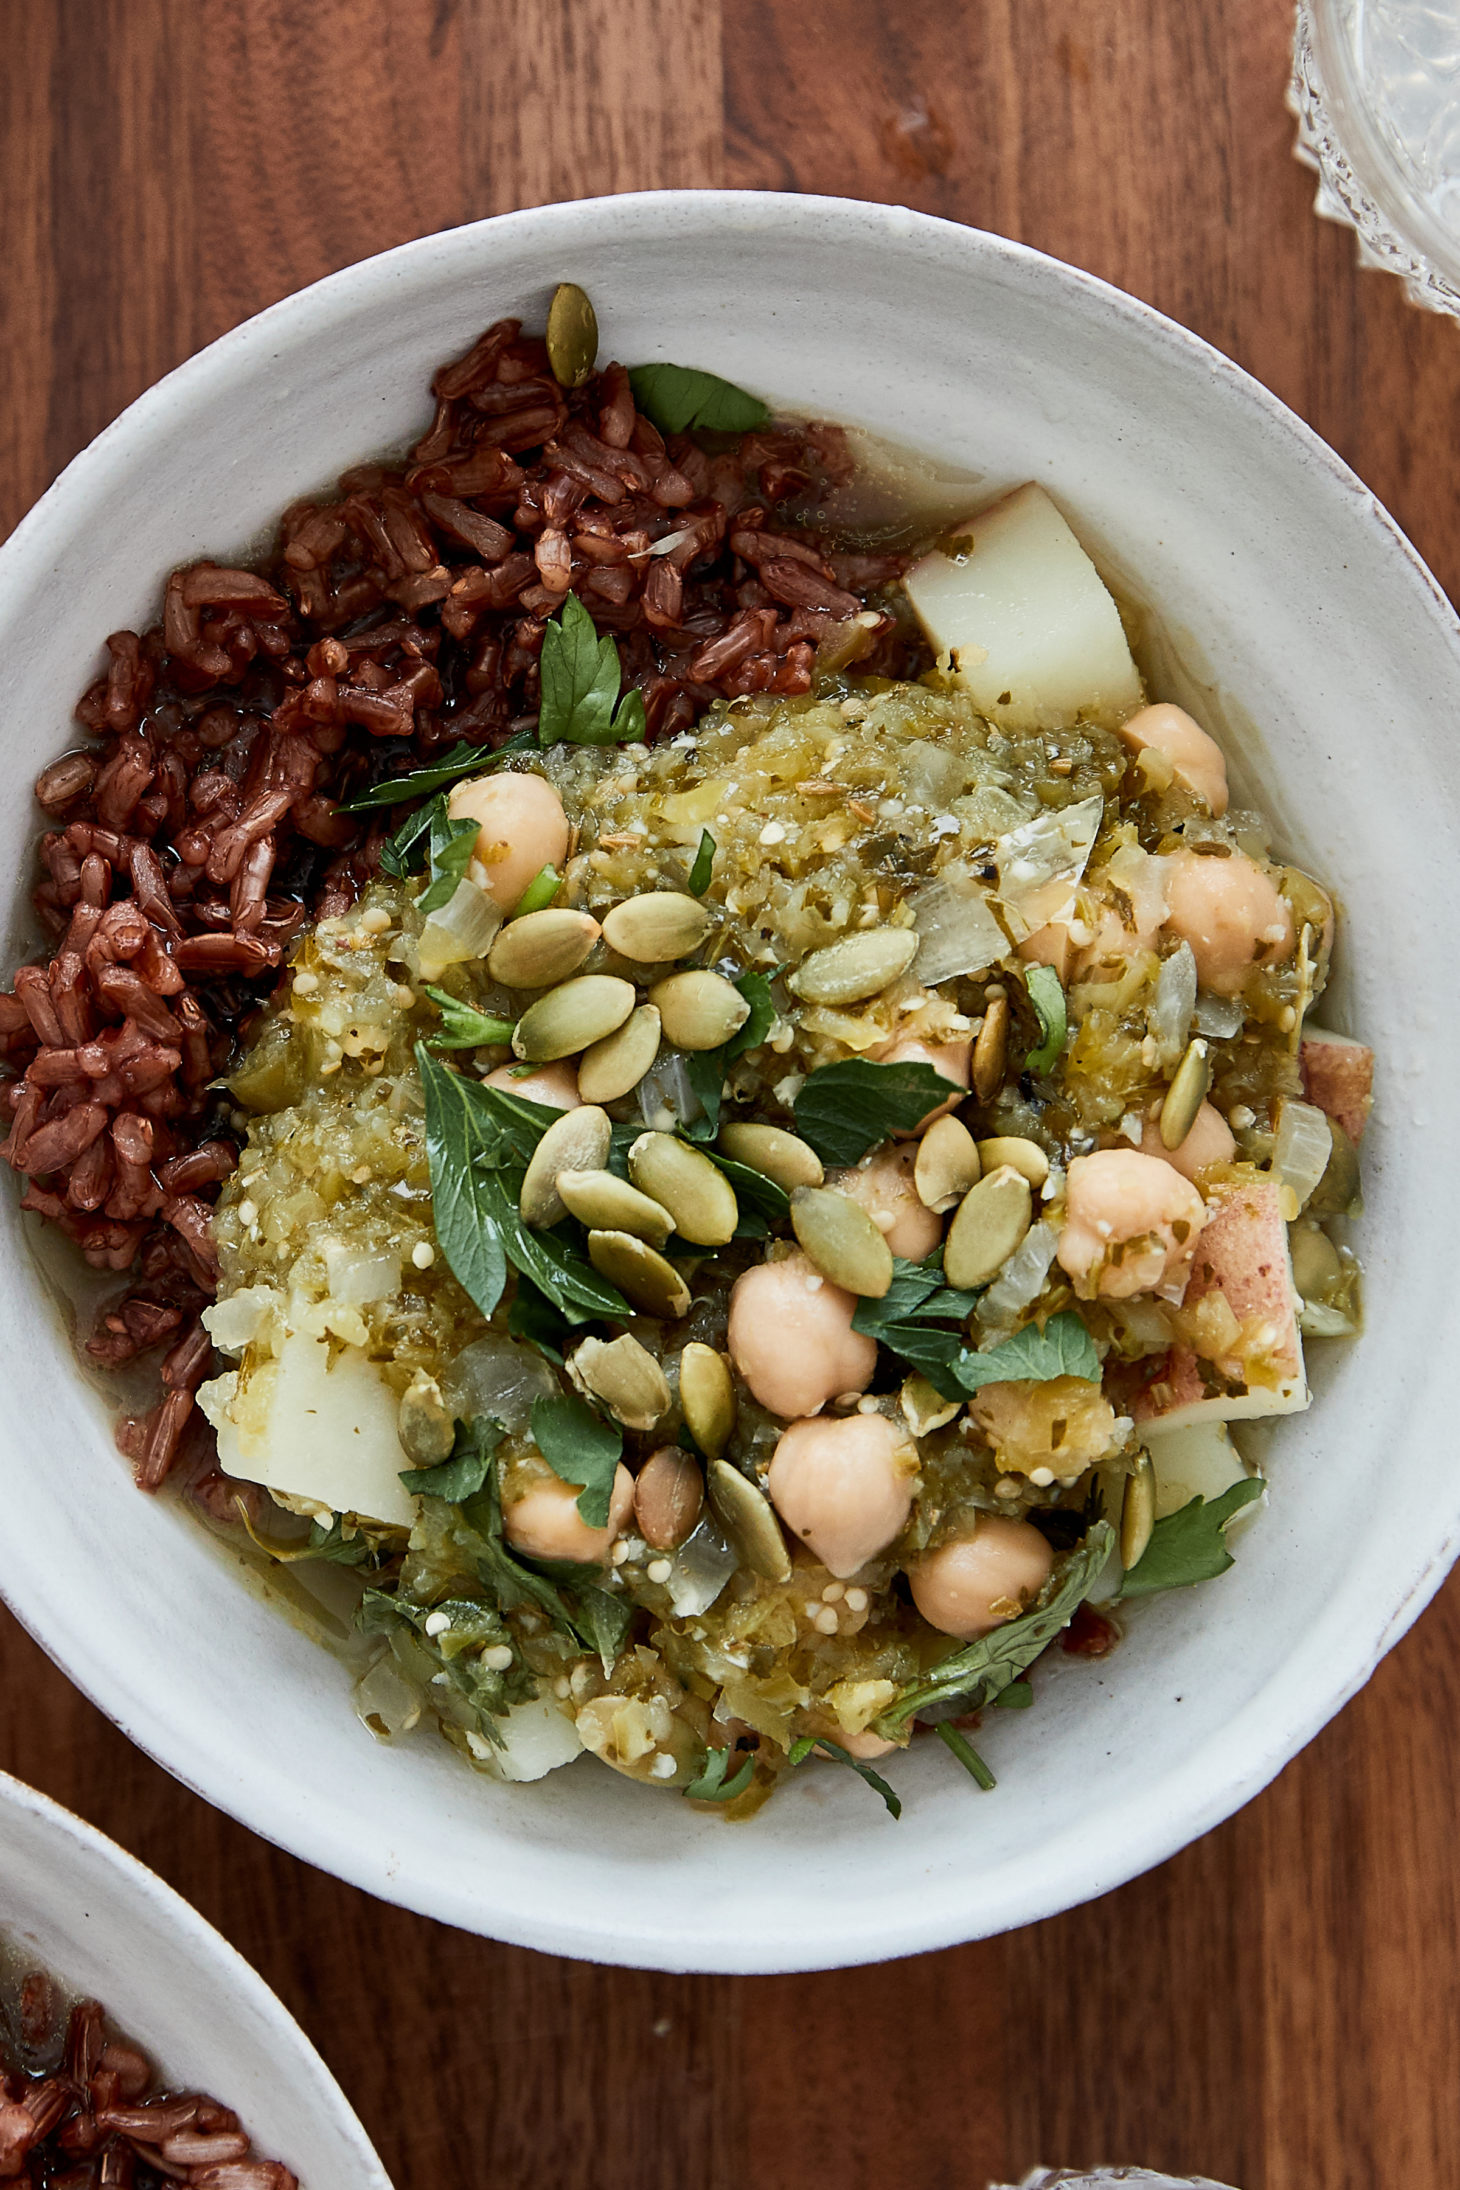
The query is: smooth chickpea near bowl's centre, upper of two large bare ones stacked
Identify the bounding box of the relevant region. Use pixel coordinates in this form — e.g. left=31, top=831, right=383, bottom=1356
left=729, top=1255, right=878, bottom=1421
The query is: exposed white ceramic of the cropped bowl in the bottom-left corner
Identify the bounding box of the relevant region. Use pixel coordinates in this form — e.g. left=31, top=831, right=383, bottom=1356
left=0, top=1774, right=390, bottom=2190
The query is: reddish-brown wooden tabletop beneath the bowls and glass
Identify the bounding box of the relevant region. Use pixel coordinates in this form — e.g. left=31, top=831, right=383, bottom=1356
left=0, top=0, right=1460, bottom=2190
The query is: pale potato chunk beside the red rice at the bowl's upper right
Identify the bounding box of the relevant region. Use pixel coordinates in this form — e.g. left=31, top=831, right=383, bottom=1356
left=904, top=484, right=1143, bottom=729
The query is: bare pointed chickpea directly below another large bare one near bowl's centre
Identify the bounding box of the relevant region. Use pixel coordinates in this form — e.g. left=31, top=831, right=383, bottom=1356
left=766, top=1415, right=917, bottom=1581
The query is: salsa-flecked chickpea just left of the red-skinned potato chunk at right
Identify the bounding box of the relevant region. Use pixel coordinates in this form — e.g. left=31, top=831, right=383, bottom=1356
left=1055, top=1148, right=1206, bottom=1301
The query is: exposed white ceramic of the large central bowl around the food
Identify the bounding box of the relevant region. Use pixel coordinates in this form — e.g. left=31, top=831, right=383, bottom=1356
left=0, top=193, right=1460, bottom=1971
